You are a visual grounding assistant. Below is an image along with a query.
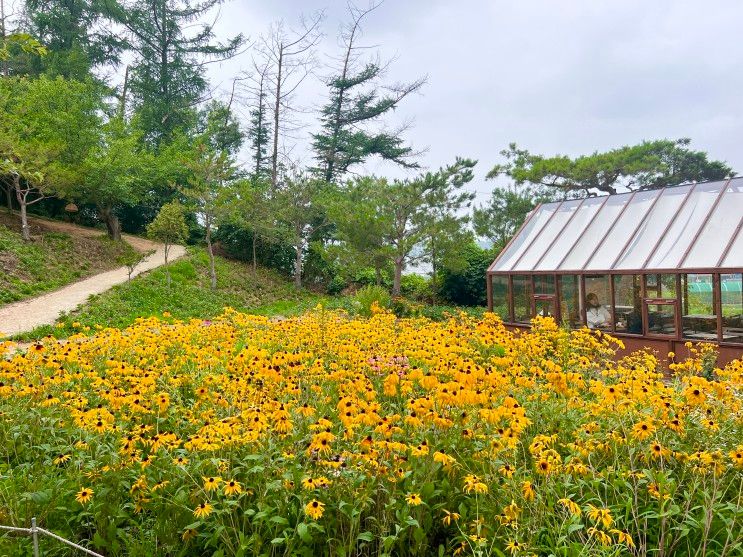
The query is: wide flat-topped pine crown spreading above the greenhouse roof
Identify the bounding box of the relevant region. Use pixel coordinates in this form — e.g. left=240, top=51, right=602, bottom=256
left=488, top=139, right=734, bottom=197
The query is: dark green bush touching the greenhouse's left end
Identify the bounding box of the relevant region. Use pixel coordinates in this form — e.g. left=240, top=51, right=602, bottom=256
left=439, top=243, right=493, bottom=306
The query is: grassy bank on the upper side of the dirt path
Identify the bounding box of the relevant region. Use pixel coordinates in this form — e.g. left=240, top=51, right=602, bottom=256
left=0, top=212, right=140, bottom=306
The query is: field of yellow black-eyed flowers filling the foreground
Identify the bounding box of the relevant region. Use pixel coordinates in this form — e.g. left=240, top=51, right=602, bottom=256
left=0, top=308, right=743, bottom=556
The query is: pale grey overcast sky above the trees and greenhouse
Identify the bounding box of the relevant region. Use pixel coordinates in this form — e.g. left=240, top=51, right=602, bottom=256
left=205, top=0, right=743, bottom=201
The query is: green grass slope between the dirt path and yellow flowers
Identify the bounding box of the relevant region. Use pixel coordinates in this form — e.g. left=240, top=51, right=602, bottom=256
left=15, top=248, right=328, bottom=340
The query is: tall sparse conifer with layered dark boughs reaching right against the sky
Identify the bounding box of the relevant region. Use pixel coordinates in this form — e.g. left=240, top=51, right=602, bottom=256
left=312, top=4, right=425, bottom=183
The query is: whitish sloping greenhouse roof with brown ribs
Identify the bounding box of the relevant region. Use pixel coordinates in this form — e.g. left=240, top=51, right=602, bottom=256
left=488, top=177, right=743, bottom=273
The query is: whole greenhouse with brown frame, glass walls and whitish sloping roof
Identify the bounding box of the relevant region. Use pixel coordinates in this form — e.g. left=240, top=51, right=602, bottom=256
left=487, top=178, right=743, bottom=360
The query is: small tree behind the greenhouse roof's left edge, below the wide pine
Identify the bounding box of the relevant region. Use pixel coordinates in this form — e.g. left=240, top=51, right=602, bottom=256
left=472, top=185, right=556, bottom=251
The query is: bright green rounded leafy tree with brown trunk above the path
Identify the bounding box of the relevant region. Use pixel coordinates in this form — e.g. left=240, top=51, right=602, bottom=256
left=76, top=117, right=154, bottom=240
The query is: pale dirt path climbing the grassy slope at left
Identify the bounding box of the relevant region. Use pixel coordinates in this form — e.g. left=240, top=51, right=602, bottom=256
left=0, top=219, right=186, bottom=338
